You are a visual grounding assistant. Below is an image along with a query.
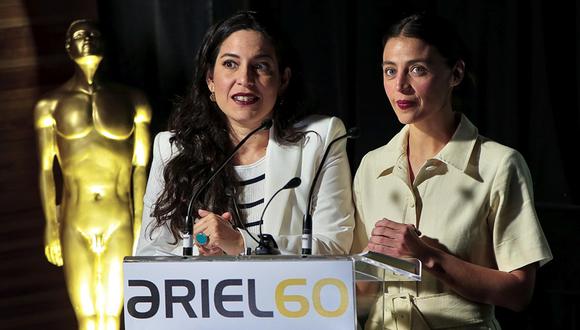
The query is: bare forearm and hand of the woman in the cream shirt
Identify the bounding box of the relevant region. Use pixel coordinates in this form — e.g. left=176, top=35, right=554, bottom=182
left=367, top=219, right=538, bottom=311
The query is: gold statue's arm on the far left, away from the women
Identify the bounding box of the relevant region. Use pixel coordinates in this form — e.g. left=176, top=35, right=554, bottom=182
left=34, top=99, right=63, bottom=266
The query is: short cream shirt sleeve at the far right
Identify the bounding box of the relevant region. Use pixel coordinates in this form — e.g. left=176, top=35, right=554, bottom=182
left=489, top=150, right=552, bottom=272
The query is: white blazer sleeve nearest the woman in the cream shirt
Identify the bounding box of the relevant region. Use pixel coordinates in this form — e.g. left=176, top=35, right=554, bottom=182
left=312, top=117, right=354, bottom=255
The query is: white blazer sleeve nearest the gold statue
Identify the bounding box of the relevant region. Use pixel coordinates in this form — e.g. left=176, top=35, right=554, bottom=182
left=135, top=133, right=181, bottom=256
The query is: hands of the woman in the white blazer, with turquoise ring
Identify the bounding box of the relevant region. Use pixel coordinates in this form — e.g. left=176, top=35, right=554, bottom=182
left=193, top=210, right=244, bottom=255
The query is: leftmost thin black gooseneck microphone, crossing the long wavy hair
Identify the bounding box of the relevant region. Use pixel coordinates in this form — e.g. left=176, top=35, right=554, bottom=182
left=183, top=119, right=272, bottom=256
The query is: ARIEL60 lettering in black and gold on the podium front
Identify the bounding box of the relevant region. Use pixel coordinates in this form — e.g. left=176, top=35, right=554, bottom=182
left=126, top=278, right=350, bottom=319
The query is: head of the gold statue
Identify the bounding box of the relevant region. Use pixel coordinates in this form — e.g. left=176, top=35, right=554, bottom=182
left=65, top=19, right=103, bottom=60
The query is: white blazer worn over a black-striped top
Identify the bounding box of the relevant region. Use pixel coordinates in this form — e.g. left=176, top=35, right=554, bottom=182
left=136, top=116, right=354, bottom=255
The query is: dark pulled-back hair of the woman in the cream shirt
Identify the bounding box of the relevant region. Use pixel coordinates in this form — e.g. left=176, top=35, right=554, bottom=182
left=383, top=12, right=475, bottom=112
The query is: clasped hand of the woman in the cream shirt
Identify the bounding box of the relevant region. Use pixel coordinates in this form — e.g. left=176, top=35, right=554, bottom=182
left=367, top=219, right=430, bottom=259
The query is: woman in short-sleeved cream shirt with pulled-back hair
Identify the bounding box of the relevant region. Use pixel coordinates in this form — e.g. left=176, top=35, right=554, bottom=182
left=353, top=14, right=552, bottom=329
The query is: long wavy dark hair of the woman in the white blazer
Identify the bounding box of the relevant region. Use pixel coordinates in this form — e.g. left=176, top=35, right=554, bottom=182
left=151, top=11, right=308, bottom=243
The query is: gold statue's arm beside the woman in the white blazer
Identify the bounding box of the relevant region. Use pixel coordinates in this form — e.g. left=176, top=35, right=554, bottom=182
left=133, top=95, right=152, bottom=251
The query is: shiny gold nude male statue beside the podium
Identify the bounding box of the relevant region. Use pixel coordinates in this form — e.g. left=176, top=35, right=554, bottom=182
left=34, top=20, right=151, bottom=330
